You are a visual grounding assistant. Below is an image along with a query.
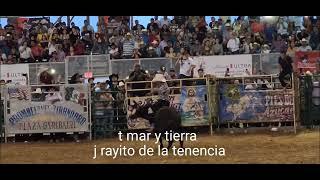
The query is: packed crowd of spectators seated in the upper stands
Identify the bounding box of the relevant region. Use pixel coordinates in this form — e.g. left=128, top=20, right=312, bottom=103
left=0, top=16, right=320, bottom=64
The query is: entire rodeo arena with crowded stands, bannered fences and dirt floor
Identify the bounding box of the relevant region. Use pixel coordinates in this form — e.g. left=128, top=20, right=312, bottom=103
left=0, top=16, right=320, bottom=163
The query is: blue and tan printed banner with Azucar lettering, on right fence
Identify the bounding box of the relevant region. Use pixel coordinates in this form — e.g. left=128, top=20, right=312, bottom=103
left=219, top=84, right=294, bottom=123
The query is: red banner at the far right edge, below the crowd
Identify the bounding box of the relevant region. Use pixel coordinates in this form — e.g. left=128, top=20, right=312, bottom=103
left=294, top=51, right=320, bottom=73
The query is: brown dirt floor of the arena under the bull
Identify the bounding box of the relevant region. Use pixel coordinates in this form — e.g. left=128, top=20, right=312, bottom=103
left=1, top=131, right=320, bottom=164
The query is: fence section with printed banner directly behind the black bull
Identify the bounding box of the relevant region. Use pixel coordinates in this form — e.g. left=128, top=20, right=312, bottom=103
left=126, top=78, right=212, bottom=129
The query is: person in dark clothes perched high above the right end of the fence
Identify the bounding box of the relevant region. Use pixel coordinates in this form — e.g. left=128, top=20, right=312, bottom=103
left=278, top=51, right=293, bottom=88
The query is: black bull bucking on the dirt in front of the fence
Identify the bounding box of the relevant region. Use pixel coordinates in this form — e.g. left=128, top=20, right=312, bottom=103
left=130, top=103, right=183, bottom=149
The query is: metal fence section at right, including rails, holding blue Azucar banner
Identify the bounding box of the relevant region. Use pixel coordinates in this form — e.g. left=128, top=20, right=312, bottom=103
left=217, top=75, right=296, bottom=131
